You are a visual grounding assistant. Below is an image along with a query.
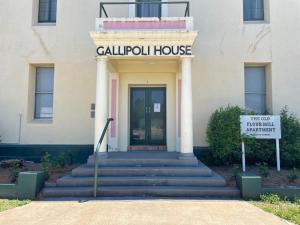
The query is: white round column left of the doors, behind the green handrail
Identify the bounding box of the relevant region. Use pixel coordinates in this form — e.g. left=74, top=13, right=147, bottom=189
left=94, top=57, right=109, bottom=153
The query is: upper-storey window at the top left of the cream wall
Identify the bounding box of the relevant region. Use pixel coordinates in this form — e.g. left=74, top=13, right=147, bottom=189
left=38, top=0, right=56, bottom=23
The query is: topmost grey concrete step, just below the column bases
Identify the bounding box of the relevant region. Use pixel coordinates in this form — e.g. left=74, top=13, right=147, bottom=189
left=87, top=156, right=199, bottom=167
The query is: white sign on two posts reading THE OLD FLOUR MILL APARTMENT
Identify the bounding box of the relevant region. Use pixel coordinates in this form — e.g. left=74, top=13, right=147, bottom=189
left=240, top=115, right=281, bottom=172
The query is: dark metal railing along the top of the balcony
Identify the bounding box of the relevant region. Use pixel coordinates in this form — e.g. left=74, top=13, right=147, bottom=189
left=99, top=1, right=190, bottom=18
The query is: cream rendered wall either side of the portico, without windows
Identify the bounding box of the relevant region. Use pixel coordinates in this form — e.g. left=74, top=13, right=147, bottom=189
left=0, top=0, right=300, bottom=149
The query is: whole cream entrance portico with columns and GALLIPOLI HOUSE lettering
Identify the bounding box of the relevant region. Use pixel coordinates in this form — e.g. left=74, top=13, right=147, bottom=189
left=90, top=18, right=197, bottom=157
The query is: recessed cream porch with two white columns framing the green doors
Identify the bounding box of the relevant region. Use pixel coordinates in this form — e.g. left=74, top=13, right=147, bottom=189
left=95, top=56, right=193, bottom=156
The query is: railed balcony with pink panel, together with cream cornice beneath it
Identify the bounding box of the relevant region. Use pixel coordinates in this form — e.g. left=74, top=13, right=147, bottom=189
left=90, top=0, right=197, bottom=55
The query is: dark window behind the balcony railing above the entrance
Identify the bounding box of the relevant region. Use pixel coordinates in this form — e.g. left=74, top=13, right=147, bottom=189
left=136, top=0, right=161, bottom=17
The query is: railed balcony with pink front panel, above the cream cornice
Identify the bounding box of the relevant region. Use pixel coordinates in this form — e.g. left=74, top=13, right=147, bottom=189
left=96, top=0, right=193, bottom=32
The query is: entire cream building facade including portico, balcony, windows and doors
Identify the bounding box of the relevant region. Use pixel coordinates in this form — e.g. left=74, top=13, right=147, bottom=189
left=0, top=0, right=300, bottom=158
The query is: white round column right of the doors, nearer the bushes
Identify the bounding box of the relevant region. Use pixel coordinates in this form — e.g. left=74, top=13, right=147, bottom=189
left=180, top=57, right=194, bottom=156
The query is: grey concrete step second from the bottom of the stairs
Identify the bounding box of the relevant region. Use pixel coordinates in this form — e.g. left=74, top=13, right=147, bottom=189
left=56, top=174, right=226, bottom=187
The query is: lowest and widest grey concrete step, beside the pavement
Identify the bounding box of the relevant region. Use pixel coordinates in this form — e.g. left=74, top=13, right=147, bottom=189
left=42, top=186, right=240, bottom=198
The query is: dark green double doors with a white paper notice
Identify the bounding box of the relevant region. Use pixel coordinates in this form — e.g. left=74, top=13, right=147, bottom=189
left=130, top=87, right=166, bottom=145
